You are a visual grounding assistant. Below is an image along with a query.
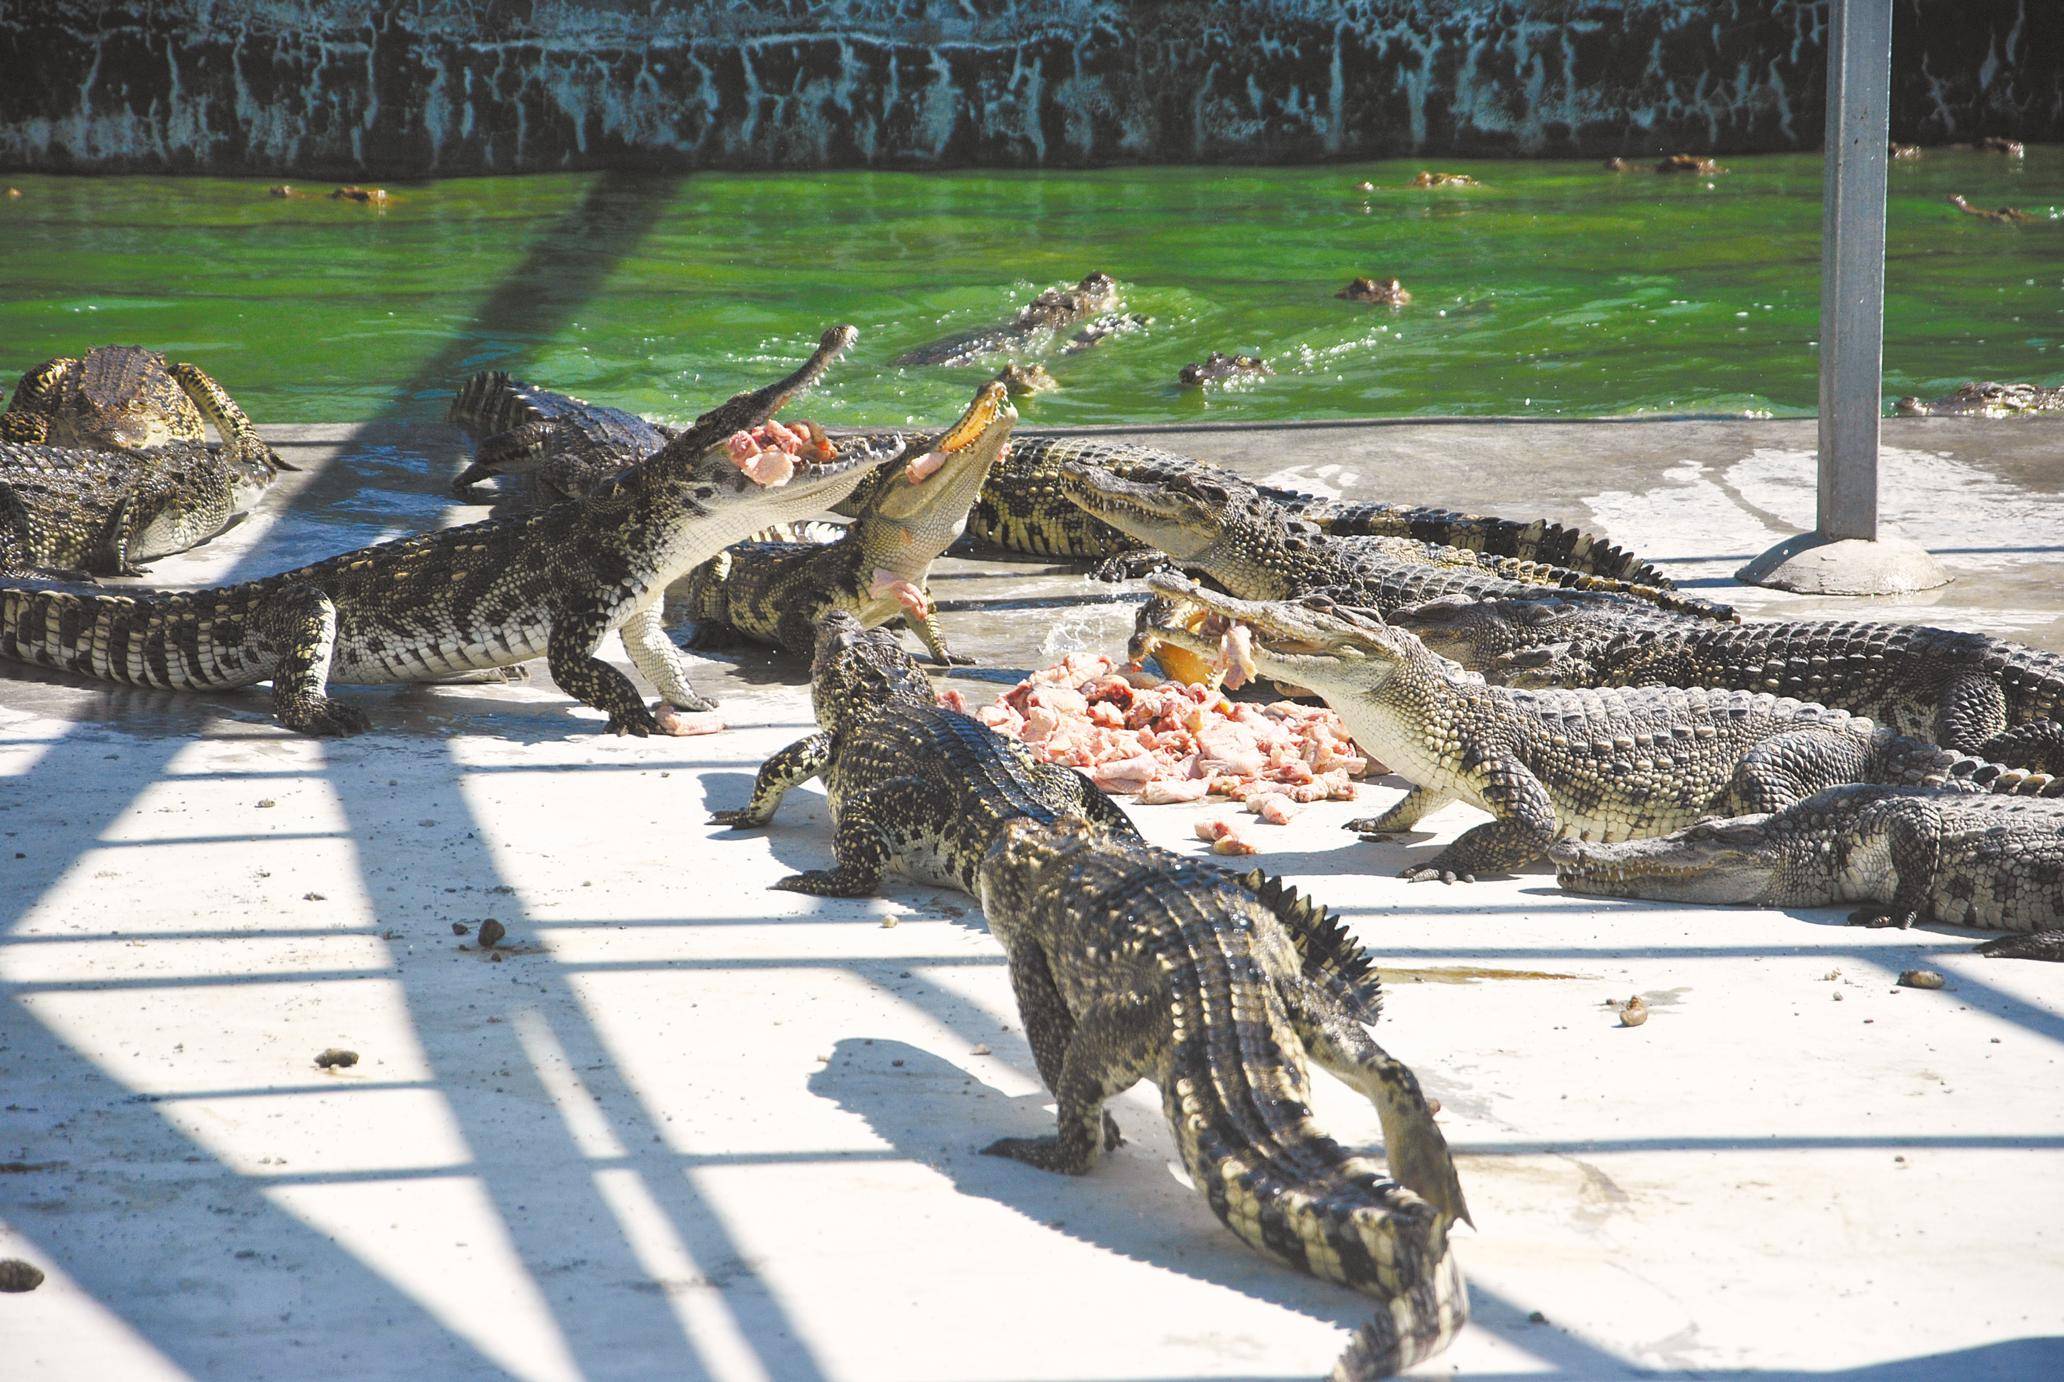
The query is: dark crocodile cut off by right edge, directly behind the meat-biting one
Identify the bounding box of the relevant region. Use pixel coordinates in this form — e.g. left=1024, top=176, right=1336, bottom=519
left=1494, top=619, right=2064, bottom=774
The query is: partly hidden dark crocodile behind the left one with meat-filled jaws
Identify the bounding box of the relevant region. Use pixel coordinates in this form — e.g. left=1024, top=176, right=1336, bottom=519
left=446, top=369, right=675, bottom=503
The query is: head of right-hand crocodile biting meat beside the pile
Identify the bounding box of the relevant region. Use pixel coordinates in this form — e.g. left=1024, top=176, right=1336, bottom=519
left=1148, top=571, right=1428, bottom=703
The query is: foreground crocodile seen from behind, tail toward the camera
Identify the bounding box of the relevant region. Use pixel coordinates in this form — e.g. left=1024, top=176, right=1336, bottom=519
left=976, top=819, right=1470, bottom=1378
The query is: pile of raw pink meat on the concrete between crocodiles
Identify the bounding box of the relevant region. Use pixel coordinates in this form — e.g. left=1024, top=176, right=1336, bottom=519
left=939, top=654, right=1381, bottom=854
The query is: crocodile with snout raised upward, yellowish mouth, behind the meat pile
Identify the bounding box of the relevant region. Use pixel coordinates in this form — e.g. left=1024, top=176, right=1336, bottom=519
left=671, top=380, right=1018, bottom=662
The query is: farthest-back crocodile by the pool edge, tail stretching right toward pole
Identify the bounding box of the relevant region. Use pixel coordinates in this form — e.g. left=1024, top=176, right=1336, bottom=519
left=904, top=433, right=1670, bottom=590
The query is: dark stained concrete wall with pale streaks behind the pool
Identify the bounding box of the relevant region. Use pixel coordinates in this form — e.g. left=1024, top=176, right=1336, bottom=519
left=0, top=0, right=2064, bottom=177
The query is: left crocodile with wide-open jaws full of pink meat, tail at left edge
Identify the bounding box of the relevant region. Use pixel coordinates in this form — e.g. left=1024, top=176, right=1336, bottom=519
left=0, top=326, right=894, bottom=736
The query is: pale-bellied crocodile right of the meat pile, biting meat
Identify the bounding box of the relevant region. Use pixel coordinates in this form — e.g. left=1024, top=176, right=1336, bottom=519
left=1150, top=573, right=2064, bottom=883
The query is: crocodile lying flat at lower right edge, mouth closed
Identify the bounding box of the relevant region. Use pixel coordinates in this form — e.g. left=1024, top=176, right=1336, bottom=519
left=1552, top=786, right=2064, bottom=959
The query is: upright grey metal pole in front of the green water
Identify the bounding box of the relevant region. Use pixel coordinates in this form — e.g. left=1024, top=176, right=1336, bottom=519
left=1818, top=0, right=1893, bottom=542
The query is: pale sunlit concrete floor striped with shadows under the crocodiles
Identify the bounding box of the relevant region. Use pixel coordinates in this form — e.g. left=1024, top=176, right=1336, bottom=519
left=0, top=419, right=2064, bottom=1380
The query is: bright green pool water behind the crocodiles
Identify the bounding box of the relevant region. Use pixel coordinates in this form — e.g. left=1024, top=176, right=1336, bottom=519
left=0, top=146, right=2064, bottom=425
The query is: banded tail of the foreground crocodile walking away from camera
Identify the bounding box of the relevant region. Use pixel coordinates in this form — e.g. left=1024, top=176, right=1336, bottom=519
left=1162, top=969, right=1470, bottom=1378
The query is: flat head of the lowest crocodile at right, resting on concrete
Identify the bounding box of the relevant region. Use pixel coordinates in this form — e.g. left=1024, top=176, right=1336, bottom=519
left=1548, top=815, right=1792, bottom=903
